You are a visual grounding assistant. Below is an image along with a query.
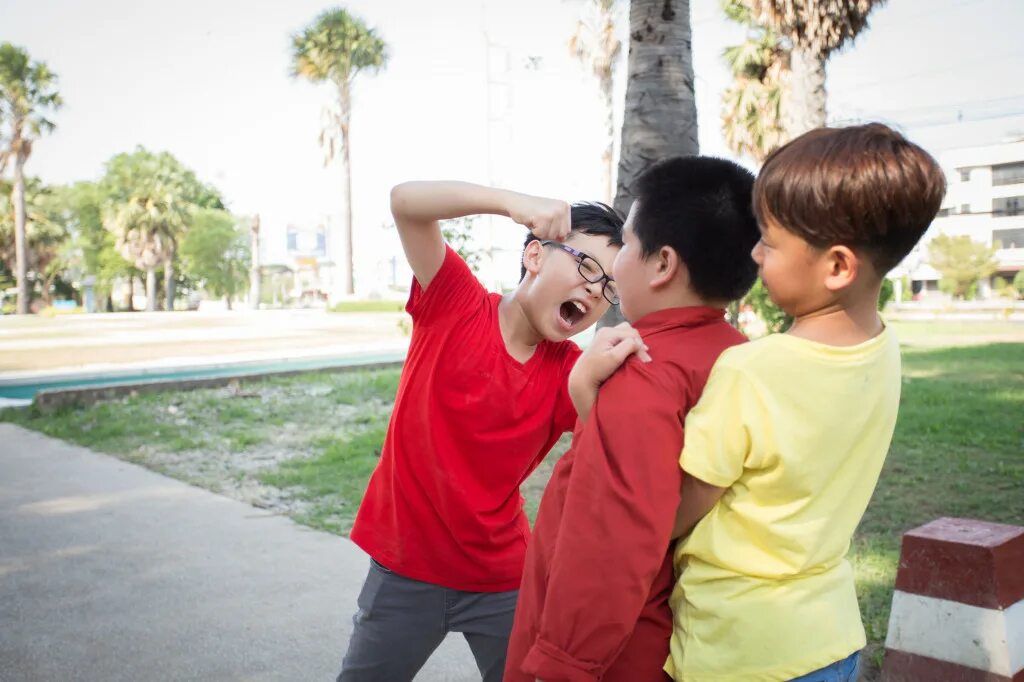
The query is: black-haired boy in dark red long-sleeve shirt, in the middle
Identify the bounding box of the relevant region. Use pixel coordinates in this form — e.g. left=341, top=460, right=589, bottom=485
left=505, top=157, right=760, bottom=682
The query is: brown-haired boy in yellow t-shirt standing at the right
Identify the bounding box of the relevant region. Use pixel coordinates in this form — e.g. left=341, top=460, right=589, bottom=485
left=666, top=124, right=945, bottom=682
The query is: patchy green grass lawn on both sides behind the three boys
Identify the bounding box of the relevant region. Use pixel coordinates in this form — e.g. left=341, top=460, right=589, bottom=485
left=0, top=323, right=1024, bottom=679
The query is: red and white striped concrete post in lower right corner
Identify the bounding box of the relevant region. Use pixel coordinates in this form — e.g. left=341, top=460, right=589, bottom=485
left=882, top=518, right=1024, bottom=682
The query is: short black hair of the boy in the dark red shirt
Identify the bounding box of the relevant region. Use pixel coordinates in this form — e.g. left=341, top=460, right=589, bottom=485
left=633, top=157, right=761, bottom=301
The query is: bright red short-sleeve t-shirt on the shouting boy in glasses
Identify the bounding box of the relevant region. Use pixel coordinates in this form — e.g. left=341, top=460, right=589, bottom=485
left=351, top=248, right=580, bottom=592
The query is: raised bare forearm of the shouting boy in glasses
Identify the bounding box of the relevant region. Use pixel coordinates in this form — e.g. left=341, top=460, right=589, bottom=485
left=391, top=180, right=518, bottom=226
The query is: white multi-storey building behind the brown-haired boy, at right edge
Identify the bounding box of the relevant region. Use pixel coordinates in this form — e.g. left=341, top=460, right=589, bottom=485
left=891, top=138, right=1024, bottom=298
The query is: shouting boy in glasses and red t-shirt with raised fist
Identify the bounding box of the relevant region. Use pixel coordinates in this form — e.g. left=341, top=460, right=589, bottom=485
left=338, top=182, right=622, bottom=682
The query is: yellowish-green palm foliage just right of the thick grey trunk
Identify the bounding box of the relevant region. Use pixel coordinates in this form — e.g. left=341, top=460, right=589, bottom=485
left=722, top=0, right=790, bottom=164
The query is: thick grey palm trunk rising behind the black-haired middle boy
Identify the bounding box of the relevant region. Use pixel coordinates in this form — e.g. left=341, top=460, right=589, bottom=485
left=598, top=0, right=698, bottom=327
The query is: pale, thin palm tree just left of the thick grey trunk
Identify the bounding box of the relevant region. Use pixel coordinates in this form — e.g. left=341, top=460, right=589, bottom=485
left=569, top=0, right=623, bottom=204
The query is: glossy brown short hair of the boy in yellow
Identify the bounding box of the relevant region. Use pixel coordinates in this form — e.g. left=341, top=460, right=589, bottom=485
left=754, top=123, right=946, bottom=276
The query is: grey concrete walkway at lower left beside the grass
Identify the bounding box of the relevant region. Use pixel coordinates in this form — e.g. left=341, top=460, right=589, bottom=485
left=0, top=424, right=479, bottom=682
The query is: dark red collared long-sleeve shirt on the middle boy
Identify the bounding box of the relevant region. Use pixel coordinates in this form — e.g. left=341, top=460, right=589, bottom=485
left=505, top=307, right=745, bottom=682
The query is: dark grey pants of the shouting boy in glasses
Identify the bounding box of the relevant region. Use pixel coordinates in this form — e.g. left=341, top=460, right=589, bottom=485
left=338, top=559, right=519, bottom=682
